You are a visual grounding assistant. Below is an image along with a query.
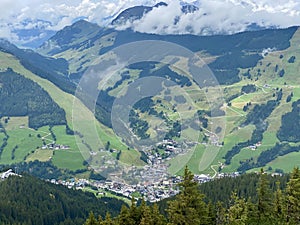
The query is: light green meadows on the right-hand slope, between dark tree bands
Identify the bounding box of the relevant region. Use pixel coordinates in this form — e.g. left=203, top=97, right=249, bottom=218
left=185, top=30, right=300, bottom=174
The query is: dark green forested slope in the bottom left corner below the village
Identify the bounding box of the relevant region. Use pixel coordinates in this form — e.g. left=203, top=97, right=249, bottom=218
left=0, top=175, right=123, bottom=225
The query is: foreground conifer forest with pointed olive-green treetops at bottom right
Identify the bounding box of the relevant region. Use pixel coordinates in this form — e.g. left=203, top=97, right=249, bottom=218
left=84, top=168, right=300, bottom=225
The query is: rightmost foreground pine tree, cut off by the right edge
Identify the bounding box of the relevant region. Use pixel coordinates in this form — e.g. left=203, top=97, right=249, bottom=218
left=286, top=168, right=300, bottom=224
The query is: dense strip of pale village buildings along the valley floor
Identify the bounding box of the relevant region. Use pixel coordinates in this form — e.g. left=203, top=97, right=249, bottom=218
left=0, top=166, right=239, bottom=202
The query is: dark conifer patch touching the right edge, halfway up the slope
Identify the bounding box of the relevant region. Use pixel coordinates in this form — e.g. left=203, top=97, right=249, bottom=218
left=277, top=100, right=300, bottom=142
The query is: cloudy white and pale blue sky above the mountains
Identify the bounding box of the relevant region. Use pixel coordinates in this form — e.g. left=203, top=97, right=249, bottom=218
left=0, top=0, right=300, bottom=45
